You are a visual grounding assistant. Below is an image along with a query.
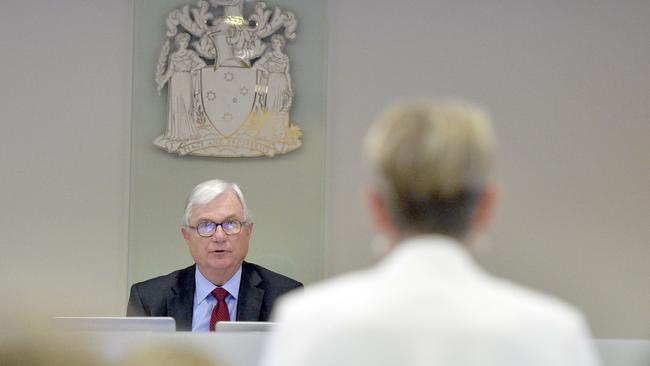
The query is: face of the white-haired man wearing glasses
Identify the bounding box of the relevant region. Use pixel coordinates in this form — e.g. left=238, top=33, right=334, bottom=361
left=181, top=190, right=253, bottom=285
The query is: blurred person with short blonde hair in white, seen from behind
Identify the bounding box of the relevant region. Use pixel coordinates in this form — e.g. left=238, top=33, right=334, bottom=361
left=262, top=100, right=598, bottom=366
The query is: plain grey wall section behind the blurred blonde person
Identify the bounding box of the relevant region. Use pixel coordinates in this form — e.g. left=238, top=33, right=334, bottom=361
left=325, top=0, right=650, bottom=338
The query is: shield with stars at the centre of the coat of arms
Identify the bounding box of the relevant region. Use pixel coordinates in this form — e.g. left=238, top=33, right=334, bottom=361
left=201, top=66, right=256, bottom=137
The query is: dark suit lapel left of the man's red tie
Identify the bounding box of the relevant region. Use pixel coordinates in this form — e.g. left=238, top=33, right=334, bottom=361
left=167, top=266, right=196, bottom=331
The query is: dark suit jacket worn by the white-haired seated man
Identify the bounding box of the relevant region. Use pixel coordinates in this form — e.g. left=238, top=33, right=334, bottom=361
left=126, top=262, right=302, bottom=330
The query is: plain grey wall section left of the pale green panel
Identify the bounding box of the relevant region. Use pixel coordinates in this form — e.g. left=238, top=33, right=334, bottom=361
left=0, top=0, right=132, bottom=324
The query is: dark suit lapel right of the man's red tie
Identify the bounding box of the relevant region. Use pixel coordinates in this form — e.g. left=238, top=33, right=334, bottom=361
left=237, top=262, right=264, bottom=321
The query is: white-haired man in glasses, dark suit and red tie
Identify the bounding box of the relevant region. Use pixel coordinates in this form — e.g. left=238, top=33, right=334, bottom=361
left=127, top=179, right=302, bottom=332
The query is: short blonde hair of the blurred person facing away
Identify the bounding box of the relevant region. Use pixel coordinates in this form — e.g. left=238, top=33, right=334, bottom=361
left=364, top=99, right=495, bottom=237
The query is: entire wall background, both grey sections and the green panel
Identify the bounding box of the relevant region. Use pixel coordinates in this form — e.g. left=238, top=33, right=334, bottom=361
left=0, top=0, right=650, bottom=338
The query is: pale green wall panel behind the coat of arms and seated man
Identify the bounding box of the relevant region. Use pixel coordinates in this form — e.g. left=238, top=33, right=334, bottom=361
left=129, top=0, right=327, bottom=286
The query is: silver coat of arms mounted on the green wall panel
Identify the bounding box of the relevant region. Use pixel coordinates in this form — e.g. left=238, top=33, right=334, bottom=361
left=154, top=0, right=302, bottom=157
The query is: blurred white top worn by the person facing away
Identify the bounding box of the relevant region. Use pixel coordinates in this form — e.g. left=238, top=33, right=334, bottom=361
left=261, top=236, right=598, bottom=366
